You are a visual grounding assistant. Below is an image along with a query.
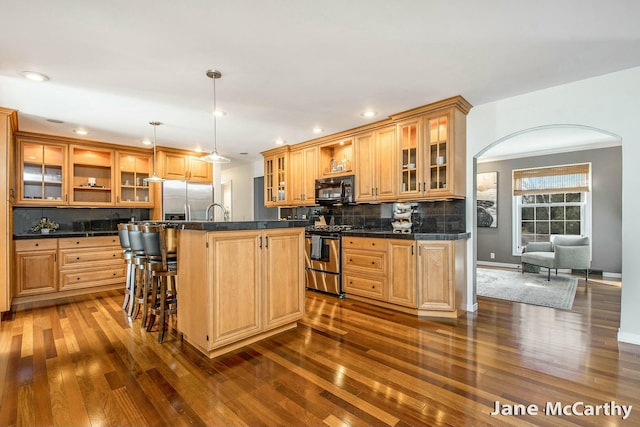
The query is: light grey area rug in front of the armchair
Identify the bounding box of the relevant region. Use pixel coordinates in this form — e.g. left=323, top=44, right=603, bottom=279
left=476, top=268, right=578, bottom=310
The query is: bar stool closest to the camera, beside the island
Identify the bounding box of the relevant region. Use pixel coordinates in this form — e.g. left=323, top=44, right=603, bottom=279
left=142, top=225, right=178, bottom=343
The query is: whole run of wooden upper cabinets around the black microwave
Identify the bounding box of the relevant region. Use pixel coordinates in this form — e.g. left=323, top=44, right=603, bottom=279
left=262, top=96, right=471, bottom=207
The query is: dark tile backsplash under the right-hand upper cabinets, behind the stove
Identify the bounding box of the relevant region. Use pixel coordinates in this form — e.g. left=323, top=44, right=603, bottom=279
left=281, top=199, right=466, bottom=233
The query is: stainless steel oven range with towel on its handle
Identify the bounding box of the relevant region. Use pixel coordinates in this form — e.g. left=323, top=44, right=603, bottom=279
left=304, top=225, right=351, bottom=298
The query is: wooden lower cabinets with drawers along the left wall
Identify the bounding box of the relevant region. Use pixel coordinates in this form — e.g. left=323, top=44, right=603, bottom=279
left=14, top=236, right=125, bottom=297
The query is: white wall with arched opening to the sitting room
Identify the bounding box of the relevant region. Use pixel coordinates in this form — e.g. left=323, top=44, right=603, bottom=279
left=467, top=67, right=640, bottom=345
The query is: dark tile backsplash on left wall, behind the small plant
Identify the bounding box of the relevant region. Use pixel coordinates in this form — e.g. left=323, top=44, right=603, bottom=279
left=13, top=207, right=150, bottom=235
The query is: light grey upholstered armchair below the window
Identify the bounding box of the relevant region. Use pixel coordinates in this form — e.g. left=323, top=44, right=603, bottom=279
left=520, top=235, right=591, bottom=281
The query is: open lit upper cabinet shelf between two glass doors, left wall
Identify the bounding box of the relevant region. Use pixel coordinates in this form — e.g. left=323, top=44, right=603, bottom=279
left=69, top=145, right=115, bottom=206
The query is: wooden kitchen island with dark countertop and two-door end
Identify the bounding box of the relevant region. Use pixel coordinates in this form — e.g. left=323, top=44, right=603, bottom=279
left=174, top=221, right=306, bottom=358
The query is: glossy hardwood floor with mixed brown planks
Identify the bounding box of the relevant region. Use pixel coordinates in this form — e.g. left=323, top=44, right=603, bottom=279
left=0, top=278, right=640, bottom=426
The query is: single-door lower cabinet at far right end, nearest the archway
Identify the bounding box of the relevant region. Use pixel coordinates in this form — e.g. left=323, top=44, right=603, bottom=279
left=417, top=240, right=466, bottom=317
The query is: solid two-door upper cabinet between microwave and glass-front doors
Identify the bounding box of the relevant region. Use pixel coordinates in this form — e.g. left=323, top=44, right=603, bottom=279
left=354, top=125, right=398, bottom=202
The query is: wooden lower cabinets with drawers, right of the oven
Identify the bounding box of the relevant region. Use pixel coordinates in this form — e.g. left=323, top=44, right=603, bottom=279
left=342, top=236, right=466, bottom=317
